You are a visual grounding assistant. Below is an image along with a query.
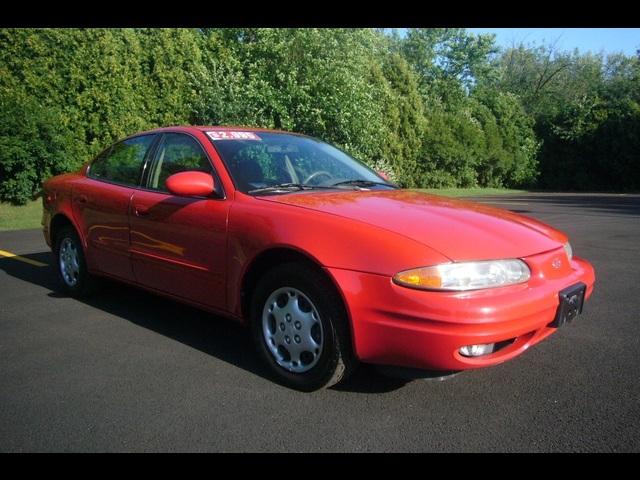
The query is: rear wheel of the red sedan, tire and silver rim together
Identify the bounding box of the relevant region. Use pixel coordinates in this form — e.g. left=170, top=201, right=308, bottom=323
left=54, top=226, right=97, bottom=297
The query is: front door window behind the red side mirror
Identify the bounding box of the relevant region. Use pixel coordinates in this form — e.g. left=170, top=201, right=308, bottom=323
left=149, top=133, right=213, bottom=192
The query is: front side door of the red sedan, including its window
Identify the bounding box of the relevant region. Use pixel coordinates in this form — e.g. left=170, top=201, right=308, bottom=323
left=130, top=132, right=230, bottom=310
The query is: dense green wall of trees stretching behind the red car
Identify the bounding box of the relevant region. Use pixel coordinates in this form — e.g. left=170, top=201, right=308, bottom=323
left=0, top=28, right=640, bottom=204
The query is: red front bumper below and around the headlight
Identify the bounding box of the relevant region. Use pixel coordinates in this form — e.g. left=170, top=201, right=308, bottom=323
left=327, top=249, right=595, bottom=370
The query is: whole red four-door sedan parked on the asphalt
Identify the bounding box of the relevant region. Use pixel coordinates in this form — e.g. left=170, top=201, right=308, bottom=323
left=43, top=127, right=595, bottom=391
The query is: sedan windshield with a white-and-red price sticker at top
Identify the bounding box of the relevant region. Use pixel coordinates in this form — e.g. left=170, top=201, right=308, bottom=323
left=207, top=131, right=393, bottom=193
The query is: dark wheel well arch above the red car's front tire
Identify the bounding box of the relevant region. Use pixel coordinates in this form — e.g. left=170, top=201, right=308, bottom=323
left=240, top=248, right=347, bottom=319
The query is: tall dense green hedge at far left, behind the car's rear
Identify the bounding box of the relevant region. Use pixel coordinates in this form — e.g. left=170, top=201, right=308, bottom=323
left=0, top=29, right=205, bottom=203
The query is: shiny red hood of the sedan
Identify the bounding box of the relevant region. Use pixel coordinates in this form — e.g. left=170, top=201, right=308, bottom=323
left=256, top=190, right=567, bottom=261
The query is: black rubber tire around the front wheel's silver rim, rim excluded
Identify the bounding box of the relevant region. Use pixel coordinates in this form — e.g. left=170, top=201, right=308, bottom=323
left=250, top=264, right=346, bottom=391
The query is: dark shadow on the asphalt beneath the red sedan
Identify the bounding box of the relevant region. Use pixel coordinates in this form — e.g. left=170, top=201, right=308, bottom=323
left=0, top=252, right=407, bottom=393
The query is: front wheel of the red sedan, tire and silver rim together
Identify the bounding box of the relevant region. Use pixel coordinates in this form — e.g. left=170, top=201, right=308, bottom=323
left=250, top=263, right=357, bottom=392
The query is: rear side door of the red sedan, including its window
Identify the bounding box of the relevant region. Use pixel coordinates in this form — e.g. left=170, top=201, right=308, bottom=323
left=72, top=134, right=157, bottom=280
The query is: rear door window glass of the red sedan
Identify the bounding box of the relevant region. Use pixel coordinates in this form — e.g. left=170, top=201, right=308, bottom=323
left=89, top=135, right=155, bottom=186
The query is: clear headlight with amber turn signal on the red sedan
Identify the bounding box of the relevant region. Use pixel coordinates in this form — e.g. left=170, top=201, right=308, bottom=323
left=393, top=259, right=531, bottom=290
